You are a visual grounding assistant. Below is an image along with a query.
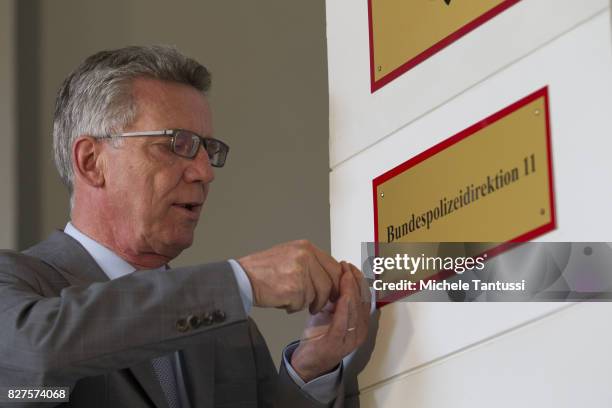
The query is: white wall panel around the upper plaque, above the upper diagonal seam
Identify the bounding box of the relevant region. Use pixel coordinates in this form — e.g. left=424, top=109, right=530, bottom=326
left=327, top=0, right=609, bottom=168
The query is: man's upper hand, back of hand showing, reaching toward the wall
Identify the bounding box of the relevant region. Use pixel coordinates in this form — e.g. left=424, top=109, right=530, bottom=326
left=238, top=241, right=342, bottom=314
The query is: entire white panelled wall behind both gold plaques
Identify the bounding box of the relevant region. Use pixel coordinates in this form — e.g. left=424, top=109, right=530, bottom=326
left=327, top=0, right=612, bottom=407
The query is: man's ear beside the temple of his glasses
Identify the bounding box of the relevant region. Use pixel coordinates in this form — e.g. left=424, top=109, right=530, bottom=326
left=72, top=136, right=104, bottom=187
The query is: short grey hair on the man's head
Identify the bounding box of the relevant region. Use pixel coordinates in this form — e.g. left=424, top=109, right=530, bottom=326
left=53, top=46, right=210, bottom=196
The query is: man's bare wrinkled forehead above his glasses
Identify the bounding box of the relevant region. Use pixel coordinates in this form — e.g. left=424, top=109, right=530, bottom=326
left=129, top=77, right=212, bottom=136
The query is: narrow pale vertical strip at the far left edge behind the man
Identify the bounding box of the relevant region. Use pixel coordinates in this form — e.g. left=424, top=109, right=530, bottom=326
left=0, top=0, right=17, bottom=248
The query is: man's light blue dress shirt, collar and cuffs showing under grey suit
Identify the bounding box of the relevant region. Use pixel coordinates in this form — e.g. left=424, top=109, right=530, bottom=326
left=64, top=222, right=342, bottom=408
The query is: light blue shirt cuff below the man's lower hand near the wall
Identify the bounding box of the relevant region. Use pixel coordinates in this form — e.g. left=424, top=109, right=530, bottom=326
left=283, top=342, right=342, bottom=404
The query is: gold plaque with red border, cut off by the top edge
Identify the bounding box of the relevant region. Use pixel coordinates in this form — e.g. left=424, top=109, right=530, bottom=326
left=368, top=0, right=519, bottom=92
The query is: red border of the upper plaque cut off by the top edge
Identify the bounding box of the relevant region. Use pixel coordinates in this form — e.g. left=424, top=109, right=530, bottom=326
left=368, top=0, right=521, bottom=93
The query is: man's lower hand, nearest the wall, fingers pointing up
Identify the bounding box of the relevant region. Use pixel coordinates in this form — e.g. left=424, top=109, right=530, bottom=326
left=291, top=262, right=370, bottom=382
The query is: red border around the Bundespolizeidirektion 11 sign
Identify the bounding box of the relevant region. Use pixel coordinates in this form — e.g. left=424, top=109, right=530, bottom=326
left=372, top=86, right=557, bottom=307
